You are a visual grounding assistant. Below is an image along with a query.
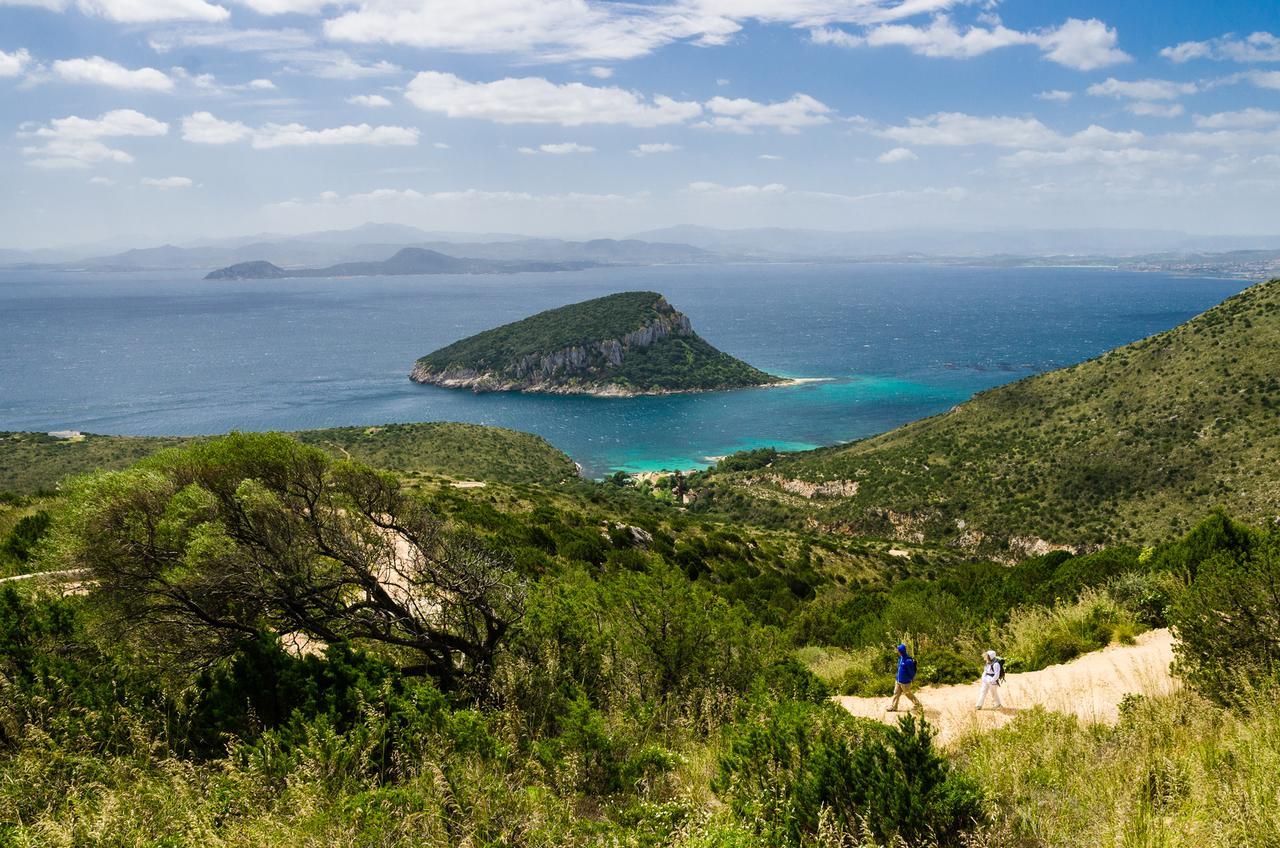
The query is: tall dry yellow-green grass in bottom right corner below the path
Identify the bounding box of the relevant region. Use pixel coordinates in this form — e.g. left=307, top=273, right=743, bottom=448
left=957, top=690, right=1280, bottom=848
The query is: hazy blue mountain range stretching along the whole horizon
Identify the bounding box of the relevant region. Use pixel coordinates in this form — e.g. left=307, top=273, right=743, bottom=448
left=0, top=223, right=1280, bottom=270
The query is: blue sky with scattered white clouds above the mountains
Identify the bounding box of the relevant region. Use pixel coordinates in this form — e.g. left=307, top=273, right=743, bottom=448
left=0, top=0, right=1280, bottom=249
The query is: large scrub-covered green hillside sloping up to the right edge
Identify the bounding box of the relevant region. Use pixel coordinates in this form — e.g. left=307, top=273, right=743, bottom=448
left=713, top=275, right=1280, bottom=555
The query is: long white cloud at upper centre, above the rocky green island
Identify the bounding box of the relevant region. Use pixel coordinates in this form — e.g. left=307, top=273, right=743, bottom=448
left=406, top=70, right=701, bottom=127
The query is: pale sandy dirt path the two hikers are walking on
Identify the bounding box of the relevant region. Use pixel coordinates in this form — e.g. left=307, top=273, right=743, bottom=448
left=836, top=630, right=1179, bottom=744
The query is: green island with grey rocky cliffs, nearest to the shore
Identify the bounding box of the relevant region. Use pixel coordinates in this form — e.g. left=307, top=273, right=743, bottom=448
left=410, top=292, right=787, bottom=397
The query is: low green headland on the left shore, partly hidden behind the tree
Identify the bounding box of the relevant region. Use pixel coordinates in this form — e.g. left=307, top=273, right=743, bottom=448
left=0, top=423, right=577, bottom=493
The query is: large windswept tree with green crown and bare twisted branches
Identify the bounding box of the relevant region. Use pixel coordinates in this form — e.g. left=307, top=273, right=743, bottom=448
left=54, top=434, right=524, bottom=689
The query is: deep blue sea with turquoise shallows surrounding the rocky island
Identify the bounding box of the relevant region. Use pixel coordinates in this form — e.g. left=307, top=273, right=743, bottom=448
left=0, top=264, right=1245, bottom=475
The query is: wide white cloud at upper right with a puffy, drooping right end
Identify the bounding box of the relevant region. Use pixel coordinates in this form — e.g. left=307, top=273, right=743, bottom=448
left=810, top=15, right=1130, bottom=70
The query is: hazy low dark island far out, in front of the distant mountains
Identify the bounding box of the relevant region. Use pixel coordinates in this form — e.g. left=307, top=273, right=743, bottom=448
left=205, top=247, right=599, bottom=279
